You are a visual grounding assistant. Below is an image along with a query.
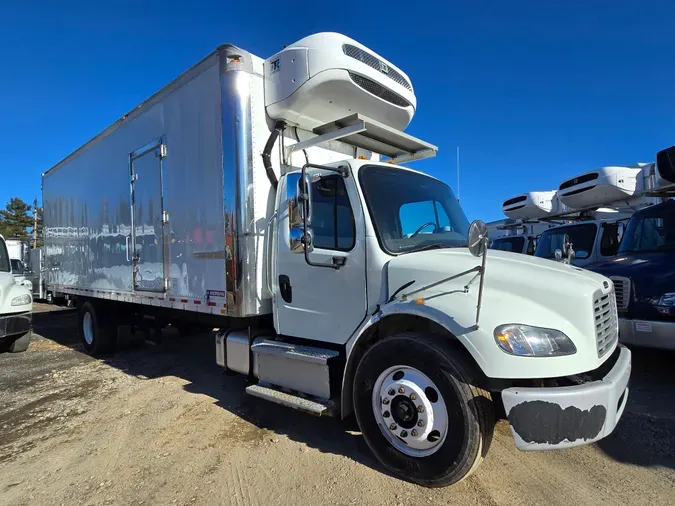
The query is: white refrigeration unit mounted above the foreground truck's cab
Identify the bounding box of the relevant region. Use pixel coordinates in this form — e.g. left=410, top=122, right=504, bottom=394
left=264, top=33, right=417, bottom=130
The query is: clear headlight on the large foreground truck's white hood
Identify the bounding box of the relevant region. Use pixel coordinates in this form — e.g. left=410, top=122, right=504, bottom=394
left=494, top=324, right=577, bottom=357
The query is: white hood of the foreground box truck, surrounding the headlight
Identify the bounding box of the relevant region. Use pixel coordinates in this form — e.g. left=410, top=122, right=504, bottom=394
left=388, top=248, right=616, bottom=378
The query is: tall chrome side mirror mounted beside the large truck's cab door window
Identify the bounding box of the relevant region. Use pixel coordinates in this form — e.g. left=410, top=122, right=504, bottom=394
left=286, top=173, right=312, bottom=253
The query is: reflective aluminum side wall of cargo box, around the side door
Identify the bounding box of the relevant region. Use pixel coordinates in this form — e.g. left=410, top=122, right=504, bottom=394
left=43, top=54, right=225, bottom=310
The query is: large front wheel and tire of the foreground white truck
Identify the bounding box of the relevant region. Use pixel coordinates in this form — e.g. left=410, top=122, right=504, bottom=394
left=353, top=333, right=495, bottom=487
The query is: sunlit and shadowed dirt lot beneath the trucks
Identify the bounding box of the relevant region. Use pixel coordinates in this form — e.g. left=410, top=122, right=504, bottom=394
left=0, top=306, right=675, bottom=506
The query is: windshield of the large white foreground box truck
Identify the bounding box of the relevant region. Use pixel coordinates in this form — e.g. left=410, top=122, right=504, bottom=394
left=359, top=166, right=469, bottom=255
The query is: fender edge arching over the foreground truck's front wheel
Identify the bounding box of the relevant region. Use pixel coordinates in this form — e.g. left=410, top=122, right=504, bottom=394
left=340, top=299, right=484, bottom=418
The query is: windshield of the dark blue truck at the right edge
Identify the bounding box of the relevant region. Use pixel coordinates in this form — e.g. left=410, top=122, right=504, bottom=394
left=619, top=202, right=675, bottom=253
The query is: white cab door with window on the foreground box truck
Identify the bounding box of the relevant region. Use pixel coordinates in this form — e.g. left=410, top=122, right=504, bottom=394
left=271, top=169, right=367, bottom=343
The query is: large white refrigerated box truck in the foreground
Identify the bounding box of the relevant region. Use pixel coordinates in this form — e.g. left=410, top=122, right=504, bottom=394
left=43, top=33, right=630, bottom=486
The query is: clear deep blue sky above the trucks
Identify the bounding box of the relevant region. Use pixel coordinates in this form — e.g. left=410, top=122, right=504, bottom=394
left=0, top=0, right=675, bottom=221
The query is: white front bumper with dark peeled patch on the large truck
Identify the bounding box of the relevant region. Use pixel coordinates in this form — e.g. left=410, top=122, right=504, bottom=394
left=502, top=346, right=631, bottom=450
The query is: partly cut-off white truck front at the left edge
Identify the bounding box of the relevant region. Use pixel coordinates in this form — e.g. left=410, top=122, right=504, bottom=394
left=0, top=235, right=33, bottom=353
